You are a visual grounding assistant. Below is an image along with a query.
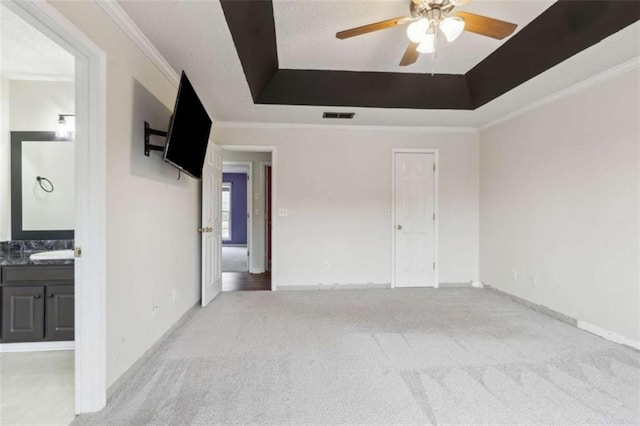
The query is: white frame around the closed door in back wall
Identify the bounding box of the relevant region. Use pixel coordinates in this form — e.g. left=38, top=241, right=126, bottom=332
left=390, top=148, right=440, bottom=288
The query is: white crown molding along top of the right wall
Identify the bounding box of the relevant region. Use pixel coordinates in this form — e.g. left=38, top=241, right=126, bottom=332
left=479, top=56, right=640, bottom=131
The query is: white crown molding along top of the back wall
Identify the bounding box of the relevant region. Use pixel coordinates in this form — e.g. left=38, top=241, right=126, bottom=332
left=213, top=121, right=478, bottom=133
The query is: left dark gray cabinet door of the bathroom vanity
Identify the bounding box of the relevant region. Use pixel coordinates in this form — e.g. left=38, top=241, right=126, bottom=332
left=2, top=286, right=44, bottom=342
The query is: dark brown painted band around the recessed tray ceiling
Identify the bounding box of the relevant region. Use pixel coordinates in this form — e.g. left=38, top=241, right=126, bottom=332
left=220, top=0, right=640, bottom=110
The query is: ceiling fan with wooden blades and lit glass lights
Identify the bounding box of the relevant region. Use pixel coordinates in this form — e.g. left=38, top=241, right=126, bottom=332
left=336, top=0, right=517, bottom=67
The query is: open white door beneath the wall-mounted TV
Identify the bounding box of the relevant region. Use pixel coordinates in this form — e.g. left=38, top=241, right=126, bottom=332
left=200, top=143, right=222, bottom=306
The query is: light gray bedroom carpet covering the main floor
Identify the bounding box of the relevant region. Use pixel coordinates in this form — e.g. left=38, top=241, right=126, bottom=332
left=76, top=289, right=640, bottom=425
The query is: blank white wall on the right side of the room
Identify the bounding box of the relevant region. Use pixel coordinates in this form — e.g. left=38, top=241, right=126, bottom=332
left=480, top=69, right=640, bottom=342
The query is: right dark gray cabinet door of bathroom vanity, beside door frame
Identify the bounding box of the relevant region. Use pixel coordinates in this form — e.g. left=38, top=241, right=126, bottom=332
left=45, top=285, right=74, bottom=340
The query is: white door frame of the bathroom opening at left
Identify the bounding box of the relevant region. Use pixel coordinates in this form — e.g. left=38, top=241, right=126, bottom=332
left=3, top=0, right=107, bottom=414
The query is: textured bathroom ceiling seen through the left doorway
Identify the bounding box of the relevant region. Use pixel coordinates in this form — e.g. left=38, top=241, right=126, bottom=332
left=0, top=5, right=75, bottom=81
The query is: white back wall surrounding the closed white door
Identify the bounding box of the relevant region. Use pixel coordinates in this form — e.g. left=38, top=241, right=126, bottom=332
left=213, top=126, right=478, bottom=287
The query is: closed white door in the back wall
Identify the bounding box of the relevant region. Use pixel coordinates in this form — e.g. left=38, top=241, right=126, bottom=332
left=393, top=153, right=436, bottom=287
